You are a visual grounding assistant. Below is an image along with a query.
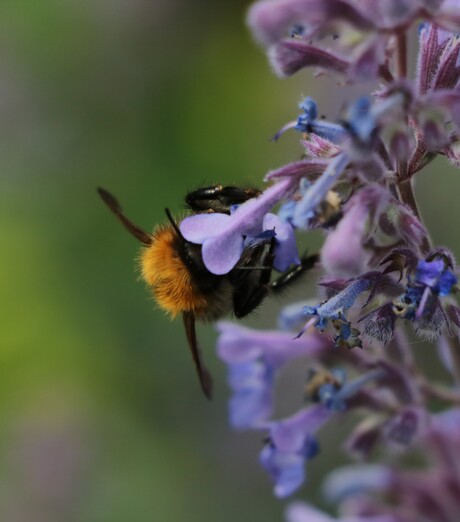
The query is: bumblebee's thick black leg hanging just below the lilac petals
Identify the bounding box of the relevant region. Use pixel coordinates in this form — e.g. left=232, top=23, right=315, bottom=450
left=233, top=238, right=275, bottom=318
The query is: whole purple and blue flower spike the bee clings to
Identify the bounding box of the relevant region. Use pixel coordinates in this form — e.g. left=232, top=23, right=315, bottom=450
left=185, top=0, right=460, bottom=522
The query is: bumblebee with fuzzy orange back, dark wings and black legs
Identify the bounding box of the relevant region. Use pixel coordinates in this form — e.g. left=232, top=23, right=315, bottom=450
left=98, top=185, right=318, bottom=399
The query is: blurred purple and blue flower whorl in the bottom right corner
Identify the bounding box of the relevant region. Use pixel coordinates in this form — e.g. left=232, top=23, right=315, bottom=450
left=286, top=408, right=460, bottom=522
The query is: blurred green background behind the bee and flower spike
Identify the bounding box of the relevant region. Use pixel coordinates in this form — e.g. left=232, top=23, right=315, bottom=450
left=0, top=0, right=459, bottom=522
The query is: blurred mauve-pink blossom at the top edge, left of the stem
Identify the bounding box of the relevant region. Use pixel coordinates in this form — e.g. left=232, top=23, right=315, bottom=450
left=248, top=0, right=385, bottom=81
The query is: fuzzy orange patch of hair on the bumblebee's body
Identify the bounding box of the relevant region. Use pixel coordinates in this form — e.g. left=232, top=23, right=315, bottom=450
left=141, top=227, right=208, bottom=317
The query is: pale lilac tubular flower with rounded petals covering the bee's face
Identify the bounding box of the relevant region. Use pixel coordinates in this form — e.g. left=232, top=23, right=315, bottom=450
left=179, top=179, right=292, bottom=275
